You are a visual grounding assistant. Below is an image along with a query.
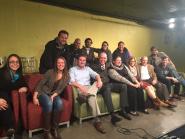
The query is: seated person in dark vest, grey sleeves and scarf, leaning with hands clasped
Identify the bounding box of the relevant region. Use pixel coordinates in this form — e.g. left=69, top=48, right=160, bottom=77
left=108, top=56, right=144, bottom=116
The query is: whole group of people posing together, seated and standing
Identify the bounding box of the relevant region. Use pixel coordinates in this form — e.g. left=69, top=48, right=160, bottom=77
left=0, top=30, right=185, bottom=139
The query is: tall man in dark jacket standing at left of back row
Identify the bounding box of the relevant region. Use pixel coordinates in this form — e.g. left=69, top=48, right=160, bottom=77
left=39, top=30, right=69, bottom=74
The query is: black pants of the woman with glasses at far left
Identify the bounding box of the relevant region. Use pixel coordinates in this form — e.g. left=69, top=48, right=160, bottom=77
left=0, top=91, right=14, bottom=130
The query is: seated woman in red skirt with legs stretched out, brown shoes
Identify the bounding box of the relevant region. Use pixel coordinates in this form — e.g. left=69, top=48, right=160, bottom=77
left=128, top=57, right=174, bottom=109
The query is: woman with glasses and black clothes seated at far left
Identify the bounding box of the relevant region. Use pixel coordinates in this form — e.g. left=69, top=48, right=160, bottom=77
left=0, top=54, right=27, bottom=139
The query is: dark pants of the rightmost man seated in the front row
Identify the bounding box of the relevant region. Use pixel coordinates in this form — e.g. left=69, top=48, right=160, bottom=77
left=160, top=79, right=180, bottom=94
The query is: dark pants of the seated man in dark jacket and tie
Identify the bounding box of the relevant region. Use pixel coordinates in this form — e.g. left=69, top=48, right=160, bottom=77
left=100, top=83, right=128, bottom=113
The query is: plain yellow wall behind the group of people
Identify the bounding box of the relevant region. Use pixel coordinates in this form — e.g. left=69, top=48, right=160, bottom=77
left=0, top=0, right=184, bottom=70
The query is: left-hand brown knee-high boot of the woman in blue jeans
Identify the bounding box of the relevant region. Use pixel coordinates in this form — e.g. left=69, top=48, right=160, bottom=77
left=43, top=112, right=52, bottom=139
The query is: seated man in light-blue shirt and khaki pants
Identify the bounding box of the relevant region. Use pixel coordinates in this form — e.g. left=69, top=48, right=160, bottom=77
left=69, top=54, right=105, bottom=134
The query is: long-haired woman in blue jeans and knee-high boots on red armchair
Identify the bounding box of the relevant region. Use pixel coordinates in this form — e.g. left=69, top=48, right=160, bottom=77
left=33, top=57, right=69, bottom=139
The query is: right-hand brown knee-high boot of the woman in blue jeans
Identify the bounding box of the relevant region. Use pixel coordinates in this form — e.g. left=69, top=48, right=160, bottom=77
left=51, top=111, right=62, bottom=139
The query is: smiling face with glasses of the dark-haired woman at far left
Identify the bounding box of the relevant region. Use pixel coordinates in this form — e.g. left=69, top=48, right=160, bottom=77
left=8, top=56, right=20, bottom=71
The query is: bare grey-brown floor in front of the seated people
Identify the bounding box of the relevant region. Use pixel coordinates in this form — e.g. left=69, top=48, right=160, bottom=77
left=19, top=98, right=185, bottom=139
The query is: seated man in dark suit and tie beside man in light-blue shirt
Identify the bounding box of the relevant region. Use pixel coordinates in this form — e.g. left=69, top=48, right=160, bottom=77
left=92, top=52, right=131, bottom=125
